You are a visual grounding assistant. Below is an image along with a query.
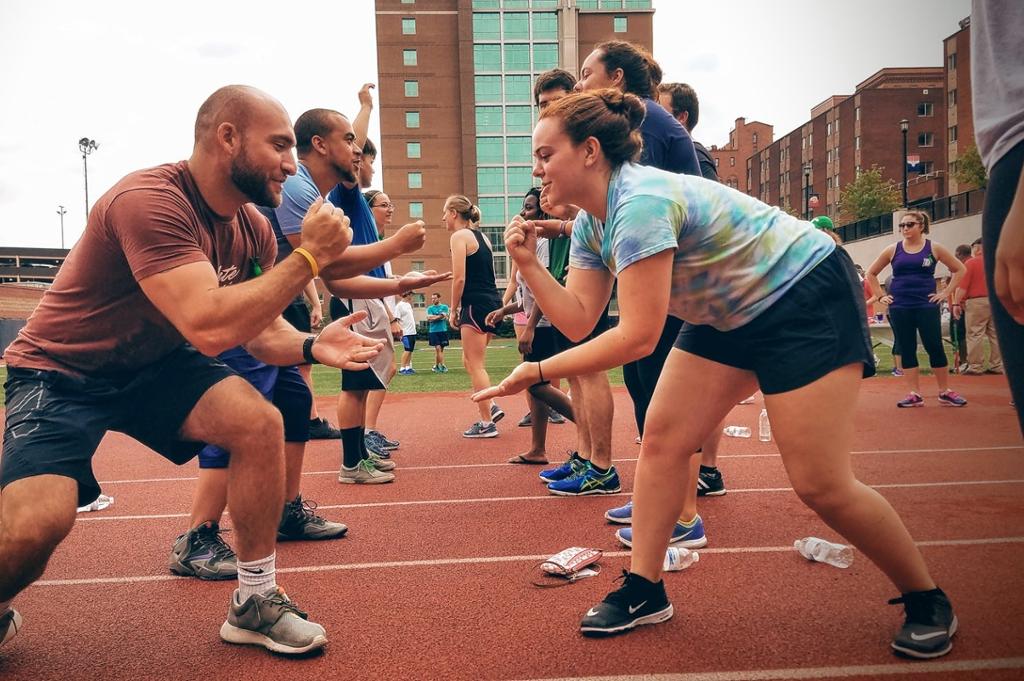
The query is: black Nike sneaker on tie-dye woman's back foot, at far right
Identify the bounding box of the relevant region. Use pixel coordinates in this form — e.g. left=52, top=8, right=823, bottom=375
left=889, top=589, right=957, bottom=659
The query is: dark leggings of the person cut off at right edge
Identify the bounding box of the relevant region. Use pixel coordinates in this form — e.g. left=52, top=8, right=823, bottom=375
left=981, top=141, right=1024, bottom=432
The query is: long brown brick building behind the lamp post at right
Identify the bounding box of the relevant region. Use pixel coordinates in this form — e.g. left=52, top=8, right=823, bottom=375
left=746, top=67, right=946, bottom=220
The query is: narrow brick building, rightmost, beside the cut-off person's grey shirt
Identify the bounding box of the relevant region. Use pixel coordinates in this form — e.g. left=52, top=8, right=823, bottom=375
left=942, top=16, right=975, bottom=195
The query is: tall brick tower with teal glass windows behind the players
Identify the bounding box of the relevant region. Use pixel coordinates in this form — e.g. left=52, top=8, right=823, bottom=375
left=376, top=0, right=654, bottom=306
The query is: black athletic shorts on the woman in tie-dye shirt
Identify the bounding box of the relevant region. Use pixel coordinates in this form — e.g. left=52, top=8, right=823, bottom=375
left=676, top=247, right=874, bottom=394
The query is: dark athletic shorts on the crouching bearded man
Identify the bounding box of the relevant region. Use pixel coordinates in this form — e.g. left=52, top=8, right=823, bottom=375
left=0, top=345, right=237, bottom=506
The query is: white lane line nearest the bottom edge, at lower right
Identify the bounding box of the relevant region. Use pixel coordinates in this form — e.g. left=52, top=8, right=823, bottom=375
left=516, top=657, right=1024, bottom=681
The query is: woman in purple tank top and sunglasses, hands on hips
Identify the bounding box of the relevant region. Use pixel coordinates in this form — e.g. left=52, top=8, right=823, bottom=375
left=864, top=211, right=967, bottom=407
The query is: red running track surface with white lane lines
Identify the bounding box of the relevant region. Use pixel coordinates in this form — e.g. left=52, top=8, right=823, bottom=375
left=0, top=377, right=1024, bottom=681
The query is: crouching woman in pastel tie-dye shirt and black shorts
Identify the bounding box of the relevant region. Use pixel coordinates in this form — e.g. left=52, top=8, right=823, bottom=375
left=474, top=90, right=956, bottom=657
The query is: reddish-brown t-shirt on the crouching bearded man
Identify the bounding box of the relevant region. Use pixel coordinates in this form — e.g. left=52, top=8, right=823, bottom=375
left=4, top=161, right=278, bottom=378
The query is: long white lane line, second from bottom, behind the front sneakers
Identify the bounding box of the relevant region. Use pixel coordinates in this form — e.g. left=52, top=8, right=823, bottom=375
left=32, top=537, right=1024, bottom=587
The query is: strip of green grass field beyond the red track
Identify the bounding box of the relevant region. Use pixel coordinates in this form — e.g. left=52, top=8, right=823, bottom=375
left=0, top=338, right=952, bottom=405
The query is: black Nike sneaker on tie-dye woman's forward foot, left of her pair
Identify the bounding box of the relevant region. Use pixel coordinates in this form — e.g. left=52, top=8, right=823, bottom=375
left=580, top=570, right=672, bottom=636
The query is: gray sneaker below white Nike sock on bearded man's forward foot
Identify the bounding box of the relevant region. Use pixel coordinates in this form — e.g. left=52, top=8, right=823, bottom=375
left=220, top=587, right=327, bottom=655
